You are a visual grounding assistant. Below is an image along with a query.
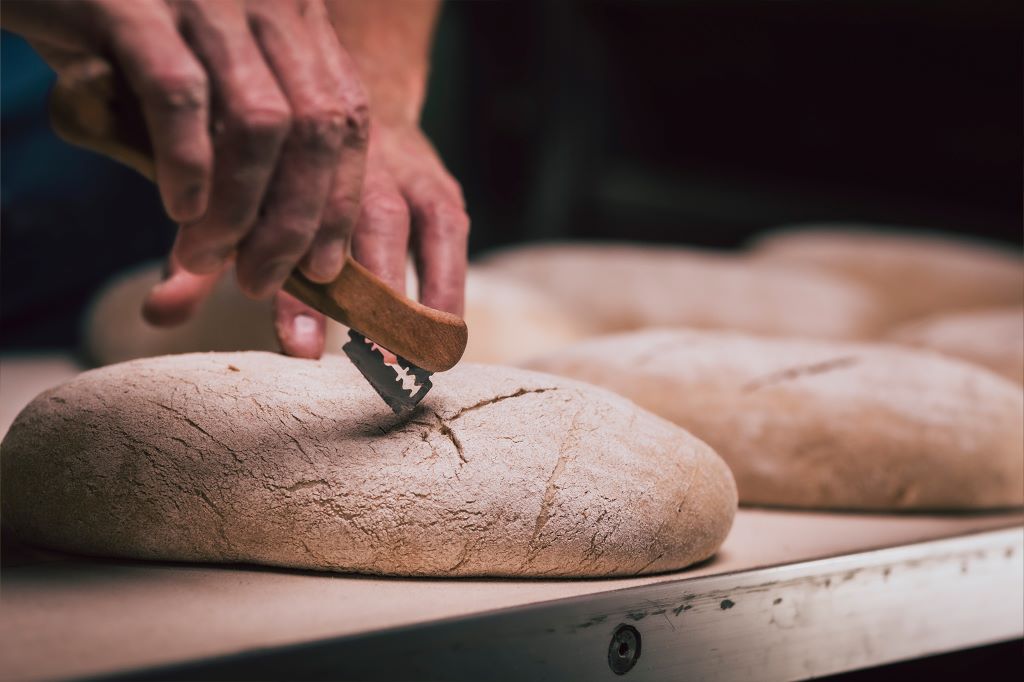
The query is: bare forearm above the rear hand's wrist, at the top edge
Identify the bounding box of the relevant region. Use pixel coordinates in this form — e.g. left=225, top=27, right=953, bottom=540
left=327, top=0, right=440, bottom=125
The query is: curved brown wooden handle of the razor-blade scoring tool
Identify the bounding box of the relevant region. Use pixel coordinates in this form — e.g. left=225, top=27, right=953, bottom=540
left=50, top=60, right=468, bottom=372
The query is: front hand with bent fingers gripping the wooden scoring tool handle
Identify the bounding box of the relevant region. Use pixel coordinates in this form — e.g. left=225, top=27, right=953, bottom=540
left=3, top=0, right=369, bottom=296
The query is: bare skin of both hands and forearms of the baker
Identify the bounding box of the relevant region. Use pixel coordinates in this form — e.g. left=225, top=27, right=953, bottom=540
left=3, top=0, right=468, bottom=357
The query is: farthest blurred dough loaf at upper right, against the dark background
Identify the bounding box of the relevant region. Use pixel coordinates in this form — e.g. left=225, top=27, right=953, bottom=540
left=754, top=224, right=1024, bottom=326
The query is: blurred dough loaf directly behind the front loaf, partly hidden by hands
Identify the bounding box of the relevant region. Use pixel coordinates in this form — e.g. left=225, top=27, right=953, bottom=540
left=85, top=263, right=585, bottom=365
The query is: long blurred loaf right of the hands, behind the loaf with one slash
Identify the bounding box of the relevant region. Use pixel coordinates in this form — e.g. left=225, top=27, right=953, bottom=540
left=470, top=244, right=881, bottom=338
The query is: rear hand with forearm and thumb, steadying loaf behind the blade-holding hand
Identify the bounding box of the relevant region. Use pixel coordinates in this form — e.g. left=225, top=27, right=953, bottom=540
left=274, top=0, right=469, bottom=357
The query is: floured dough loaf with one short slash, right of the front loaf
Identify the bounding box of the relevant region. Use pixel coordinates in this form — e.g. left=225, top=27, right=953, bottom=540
left=530, top=331, right=1024, bottom=510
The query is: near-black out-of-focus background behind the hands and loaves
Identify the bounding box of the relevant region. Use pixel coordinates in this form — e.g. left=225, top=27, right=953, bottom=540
left=0, top=0, right=1024, bottom=349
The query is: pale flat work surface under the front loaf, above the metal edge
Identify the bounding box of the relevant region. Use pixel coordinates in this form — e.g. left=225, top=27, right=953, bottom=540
left=0, top=509, right=1024, bottom=679
